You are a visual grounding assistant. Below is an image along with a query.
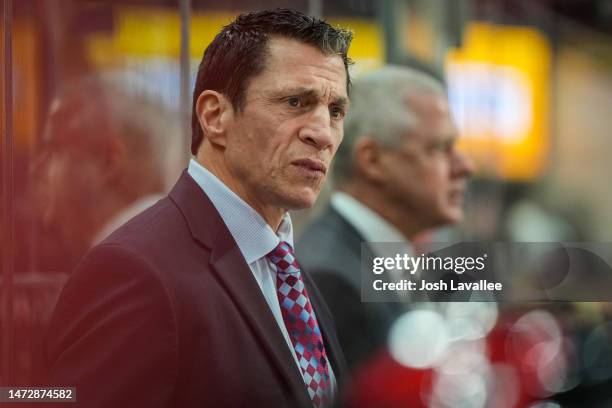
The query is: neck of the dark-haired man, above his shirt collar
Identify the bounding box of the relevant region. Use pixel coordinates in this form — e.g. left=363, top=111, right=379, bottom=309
left=196, top=153, right=286, bottom=231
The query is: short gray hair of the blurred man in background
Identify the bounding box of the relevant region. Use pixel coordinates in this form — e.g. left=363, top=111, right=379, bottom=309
left=333, top=65, right=446, bottom=183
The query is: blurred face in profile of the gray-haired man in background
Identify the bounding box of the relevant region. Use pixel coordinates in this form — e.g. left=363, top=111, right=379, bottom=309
left=383, top=94, right=473, bottom=229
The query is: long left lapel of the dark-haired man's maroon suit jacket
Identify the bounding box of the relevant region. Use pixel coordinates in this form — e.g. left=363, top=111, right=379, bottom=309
left=170, top=171, right=312, bottom=406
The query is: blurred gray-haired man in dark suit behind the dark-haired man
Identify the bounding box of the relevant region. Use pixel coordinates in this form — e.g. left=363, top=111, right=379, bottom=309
left=297, top=66, right=472, bottom=370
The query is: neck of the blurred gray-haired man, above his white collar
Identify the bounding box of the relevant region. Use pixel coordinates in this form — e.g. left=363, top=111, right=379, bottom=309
left=339, top=181, right=422, bottom=241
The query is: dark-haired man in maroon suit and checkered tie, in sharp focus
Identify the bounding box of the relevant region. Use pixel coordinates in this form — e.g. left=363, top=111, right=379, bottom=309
left=47, top=10, right=351, bottom=408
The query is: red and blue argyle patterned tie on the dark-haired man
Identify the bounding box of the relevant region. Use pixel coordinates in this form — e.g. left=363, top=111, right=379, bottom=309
left=267, top=241, right=331, bottom=407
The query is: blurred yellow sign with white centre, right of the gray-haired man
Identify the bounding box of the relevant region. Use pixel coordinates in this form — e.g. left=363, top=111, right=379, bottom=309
left=447, top=23, right=551, bottom=180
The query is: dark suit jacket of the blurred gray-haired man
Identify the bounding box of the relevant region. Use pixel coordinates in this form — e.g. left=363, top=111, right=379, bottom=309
left=296, top=207, right=404, bottom=370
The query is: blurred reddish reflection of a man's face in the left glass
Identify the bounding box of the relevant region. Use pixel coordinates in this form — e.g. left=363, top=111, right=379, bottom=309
left=34, top=98, right=111, bottom=247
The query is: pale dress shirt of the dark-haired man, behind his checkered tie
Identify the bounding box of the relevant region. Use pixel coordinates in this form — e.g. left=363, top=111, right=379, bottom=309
left=187, top=159, right=336, bottom=394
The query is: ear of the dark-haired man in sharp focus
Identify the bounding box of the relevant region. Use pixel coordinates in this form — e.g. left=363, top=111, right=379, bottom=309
left=196, top=89, right=234, bottom=147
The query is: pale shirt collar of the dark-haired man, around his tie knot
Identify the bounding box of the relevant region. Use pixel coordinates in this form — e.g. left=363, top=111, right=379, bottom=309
left=187, top=159, right=293, bottom=264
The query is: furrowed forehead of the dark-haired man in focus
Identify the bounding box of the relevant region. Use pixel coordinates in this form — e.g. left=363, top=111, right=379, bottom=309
left=251, top=37, right=348, bottom=98
